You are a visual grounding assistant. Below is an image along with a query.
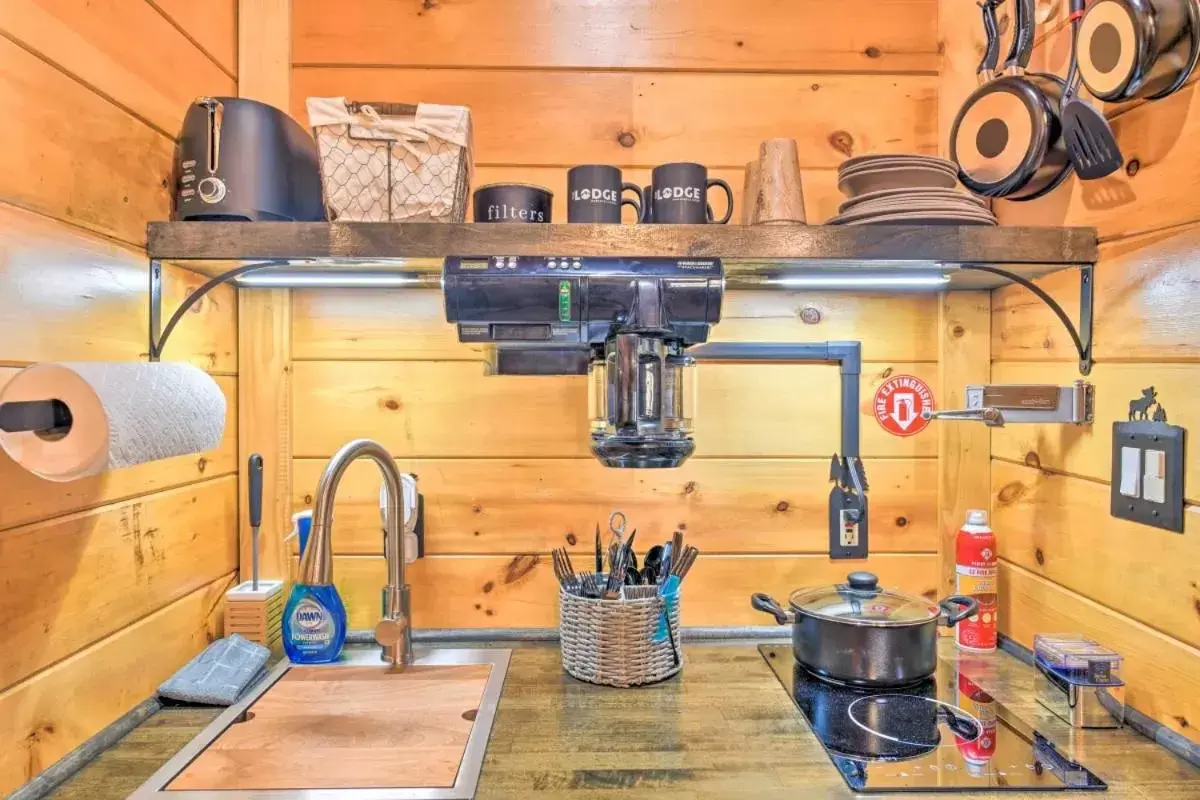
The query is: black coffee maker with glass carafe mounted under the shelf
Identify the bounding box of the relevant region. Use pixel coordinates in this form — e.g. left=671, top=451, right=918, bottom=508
left=443, top=255, right=725, bottom=468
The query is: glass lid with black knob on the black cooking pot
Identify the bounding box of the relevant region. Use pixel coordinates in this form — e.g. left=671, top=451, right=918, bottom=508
left=788, top=572, right=942, bottom=625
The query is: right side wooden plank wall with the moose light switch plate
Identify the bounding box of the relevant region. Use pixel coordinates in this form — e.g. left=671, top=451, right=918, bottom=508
left=991, top=12, right=1200, bottom=741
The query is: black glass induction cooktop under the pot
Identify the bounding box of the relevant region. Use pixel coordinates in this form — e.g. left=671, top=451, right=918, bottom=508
left=758, top=645, right=1108, bottom=794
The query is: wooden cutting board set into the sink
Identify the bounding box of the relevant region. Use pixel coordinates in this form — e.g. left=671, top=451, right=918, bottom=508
left=168, top=664, right=491, bottom=790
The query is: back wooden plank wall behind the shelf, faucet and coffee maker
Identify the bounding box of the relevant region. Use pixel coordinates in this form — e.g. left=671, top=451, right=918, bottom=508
left=292, top=0, right=945, bottom=628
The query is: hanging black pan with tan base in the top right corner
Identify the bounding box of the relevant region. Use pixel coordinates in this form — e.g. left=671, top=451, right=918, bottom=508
left=1078, top=0, right=1200, bottom=103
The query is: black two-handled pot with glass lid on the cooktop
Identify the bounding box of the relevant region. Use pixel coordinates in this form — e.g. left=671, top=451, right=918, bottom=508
left=750, top=572, right=979, bottom=687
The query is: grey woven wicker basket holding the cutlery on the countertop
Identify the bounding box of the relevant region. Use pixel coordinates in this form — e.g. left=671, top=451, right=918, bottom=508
left=558, top=587, right=683, bottom=687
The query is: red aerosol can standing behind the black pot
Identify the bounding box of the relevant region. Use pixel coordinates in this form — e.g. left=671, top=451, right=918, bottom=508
left=954, top=510, right=998, bottom=651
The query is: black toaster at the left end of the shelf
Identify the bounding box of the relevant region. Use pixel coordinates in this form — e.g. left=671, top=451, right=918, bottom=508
left=172, top=97, right=325, bottom=222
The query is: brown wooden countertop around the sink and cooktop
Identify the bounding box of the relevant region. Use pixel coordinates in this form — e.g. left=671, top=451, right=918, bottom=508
left=44, top=642, right=1200, bottom=800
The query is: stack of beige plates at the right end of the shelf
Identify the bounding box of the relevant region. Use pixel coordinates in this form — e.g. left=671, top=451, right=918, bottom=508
left=827, top=155, right=997, bottom=225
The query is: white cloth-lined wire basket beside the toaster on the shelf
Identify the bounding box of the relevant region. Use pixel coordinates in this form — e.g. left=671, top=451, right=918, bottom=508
left=307, top=97, right=472, bottom=222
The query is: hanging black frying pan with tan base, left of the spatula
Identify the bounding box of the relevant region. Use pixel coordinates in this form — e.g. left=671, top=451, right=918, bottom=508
left=950, top=0, right=1070, bottom=200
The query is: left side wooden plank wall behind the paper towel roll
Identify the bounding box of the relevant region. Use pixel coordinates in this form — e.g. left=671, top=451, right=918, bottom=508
left=0, top=0, right=239, bottom=794
